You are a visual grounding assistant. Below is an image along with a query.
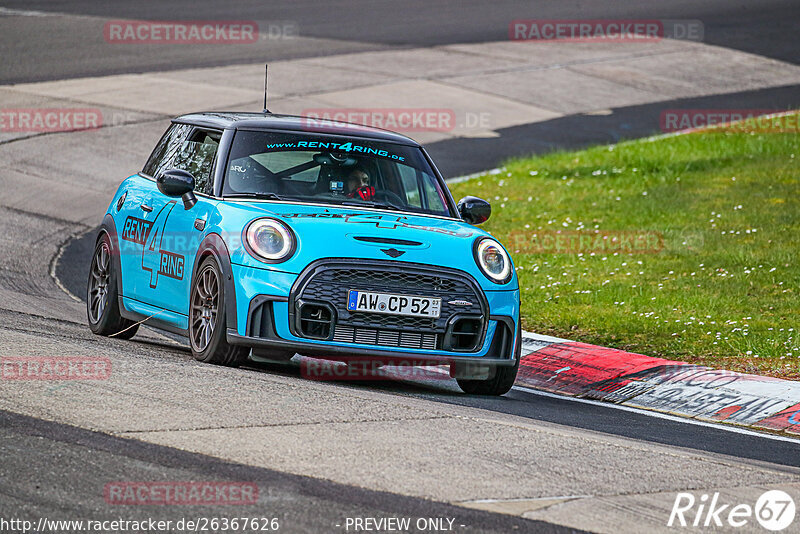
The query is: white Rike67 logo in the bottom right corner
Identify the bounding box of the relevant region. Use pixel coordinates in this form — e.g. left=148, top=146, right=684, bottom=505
left=667, top=490, right=796, bottom=532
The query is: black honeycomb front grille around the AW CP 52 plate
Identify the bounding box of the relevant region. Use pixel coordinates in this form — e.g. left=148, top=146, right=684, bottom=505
left=289, top=260, right=488, bottom=352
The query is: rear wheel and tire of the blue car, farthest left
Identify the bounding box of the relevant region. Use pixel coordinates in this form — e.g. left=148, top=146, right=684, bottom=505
left=86, top=232, right=139, bottom=339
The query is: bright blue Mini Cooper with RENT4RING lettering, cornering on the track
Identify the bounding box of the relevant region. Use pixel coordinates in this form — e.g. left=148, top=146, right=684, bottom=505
left=87, top=112, right=521, bottom=395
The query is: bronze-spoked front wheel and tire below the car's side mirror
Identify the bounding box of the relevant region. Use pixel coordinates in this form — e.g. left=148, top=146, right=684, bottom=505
left=189, top=256, right=250, bottom=367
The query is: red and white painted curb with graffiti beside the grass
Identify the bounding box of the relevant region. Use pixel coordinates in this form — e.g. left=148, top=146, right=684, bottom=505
left=516, top=332, right=800, bottom=435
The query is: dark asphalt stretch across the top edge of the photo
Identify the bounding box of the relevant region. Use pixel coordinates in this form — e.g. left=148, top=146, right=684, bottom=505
left=0, top=0, right=800, bottom=83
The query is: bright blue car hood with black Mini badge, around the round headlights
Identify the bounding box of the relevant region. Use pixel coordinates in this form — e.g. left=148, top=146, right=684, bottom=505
left=217, top=201, right=516, bottom=290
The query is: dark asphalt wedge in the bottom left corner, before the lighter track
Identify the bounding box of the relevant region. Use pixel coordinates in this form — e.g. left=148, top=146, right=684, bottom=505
left=0, top=410, right=579, bottom=533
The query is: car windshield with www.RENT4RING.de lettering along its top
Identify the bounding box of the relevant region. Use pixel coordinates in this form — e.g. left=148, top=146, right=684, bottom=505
left=223, top=130, right=453, bottom=217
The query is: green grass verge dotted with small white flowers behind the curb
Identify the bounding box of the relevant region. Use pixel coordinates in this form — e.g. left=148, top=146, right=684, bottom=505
left=451, top=114, right=800, bottom=379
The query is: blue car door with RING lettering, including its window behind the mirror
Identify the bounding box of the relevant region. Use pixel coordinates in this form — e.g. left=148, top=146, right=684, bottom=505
left=142, top=128, right=222, bottom=316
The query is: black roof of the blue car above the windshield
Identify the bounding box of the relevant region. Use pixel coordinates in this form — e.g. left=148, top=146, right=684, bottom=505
left=172, top=111, right=419, bottom=146
